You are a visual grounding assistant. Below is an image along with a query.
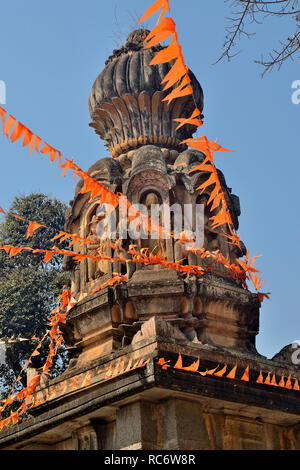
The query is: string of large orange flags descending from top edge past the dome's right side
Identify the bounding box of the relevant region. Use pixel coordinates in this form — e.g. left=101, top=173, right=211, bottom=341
left=138, top=0, right=270, bottom=301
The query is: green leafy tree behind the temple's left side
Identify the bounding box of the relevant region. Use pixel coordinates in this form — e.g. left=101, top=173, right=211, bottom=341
left=0, top=194, right=69, bottom=394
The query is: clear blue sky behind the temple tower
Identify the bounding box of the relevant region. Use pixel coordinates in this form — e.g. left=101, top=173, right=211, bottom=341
left=0, top=0, right=300, bottom=357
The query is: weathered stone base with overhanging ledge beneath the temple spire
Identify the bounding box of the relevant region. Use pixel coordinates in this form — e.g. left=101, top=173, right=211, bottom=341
left=0, top=336, right=300, bottom=450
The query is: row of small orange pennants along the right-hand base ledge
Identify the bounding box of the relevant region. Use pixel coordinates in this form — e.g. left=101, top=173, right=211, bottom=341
left=157, top=353, right=300, bottom=391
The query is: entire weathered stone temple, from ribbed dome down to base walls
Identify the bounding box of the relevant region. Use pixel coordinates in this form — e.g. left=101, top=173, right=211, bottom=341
left=0, top=29, right=300, bottom=450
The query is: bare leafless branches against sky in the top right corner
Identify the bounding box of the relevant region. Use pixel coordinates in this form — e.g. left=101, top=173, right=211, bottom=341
left=217, top=0, right=300, bottom=76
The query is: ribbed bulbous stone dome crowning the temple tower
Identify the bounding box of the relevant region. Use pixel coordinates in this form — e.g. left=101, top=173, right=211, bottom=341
left=89, top=29, right=203, bottom=158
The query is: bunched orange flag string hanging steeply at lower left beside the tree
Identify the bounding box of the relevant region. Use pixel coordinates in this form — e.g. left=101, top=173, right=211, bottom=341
left=0, top=274, right=127, bottom=431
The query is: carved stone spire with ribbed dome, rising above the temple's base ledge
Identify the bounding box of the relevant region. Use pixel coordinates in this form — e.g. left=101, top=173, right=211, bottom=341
left=61, top=29, right=253, bottom=363
